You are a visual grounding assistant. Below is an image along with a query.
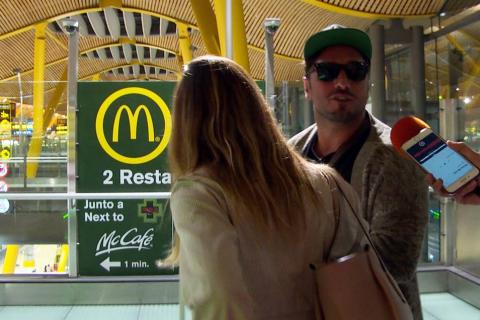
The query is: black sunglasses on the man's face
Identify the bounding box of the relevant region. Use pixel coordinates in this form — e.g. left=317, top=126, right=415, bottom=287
left=310, top=61, right=370, bottom=82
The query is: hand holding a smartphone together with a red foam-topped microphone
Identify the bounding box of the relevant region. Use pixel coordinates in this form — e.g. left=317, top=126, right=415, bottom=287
left=391, top=116, right=480, bottom=204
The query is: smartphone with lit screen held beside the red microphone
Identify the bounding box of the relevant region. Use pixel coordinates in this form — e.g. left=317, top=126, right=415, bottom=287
left=402, top=128, right=479, bottom=193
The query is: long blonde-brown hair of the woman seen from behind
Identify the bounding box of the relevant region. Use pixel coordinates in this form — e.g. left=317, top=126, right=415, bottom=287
left=169, top=56, right=318, bottom=262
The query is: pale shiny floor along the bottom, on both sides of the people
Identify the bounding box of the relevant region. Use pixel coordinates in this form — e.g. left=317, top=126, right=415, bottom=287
left=0, top=293, right=480, bottom=320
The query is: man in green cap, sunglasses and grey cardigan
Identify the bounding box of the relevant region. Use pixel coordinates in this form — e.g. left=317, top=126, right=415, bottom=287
left=289, top=25, right=428, bottom=319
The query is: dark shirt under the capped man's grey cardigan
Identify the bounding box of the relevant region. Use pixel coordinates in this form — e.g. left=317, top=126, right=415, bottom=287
left=306, top=113, right=372, bottom=182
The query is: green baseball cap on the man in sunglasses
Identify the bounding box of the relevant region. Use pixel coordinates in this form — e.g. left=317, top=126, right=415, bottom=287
left=303, top=24, right=372, bottom=60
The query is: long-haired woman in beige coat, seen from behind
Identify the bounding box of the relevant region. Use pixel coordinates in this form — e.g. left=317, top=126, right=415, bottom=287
left=167, top=56, right=364, bottom=320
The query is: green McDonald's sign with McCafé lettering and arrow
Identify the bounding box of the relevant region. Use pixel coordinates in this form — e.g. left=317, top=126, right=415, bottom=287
left=77, top=82, right=175, bottom=276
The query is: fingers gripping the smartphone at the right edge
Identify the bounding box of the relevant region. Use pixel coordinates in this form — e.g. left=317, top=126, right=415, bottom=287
left=427, top=141, right=480, bottom=205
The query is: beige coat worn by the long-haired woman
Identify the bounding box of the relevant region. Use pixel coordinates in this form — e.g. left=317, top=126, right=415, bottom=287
left=171, top=166, right=364, bottom=320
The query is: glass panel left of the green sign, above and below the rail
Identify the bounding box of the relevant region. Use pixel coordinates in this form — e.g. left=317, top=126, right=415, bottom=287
left=0, top=79, right=68, bottom=274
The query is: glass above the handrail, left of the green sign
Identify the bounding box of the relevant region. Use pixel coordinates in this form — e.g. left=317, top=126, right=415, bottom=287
left=0, top=82, right=68, bottom=192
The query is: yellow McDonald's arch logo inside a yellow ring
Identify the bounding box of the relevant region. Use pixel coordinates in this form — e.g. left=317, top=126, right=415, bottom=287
left=95, top=87, right=172, bottom=164
